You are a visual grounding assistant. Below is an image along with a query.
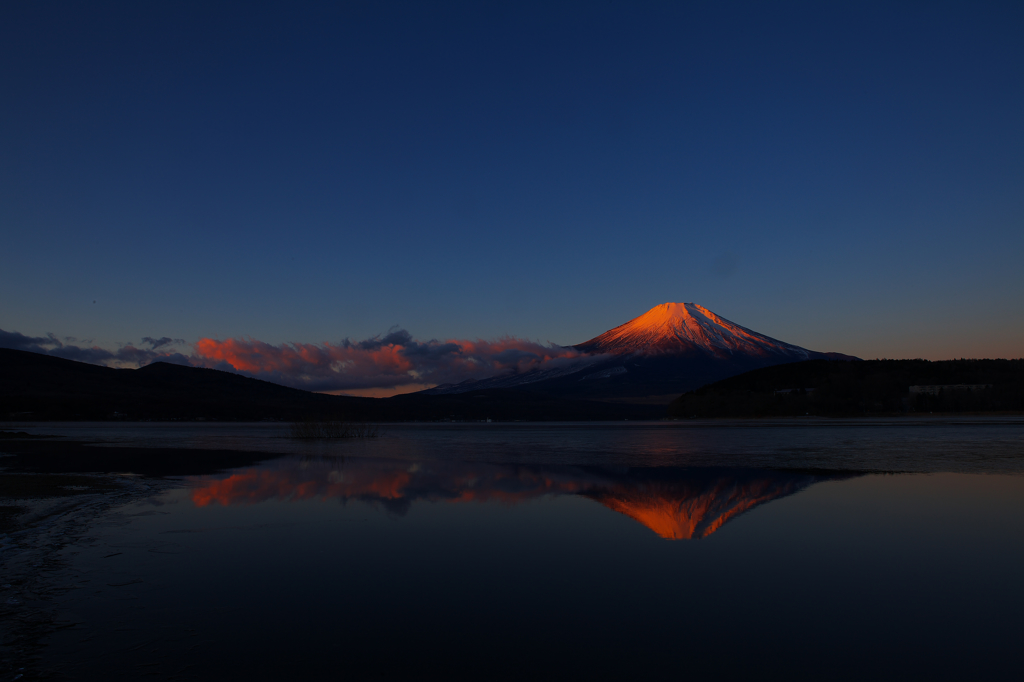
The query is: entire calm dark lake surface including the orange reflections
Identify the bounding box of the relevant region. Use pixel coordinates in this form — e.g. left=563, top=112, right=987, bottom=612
left=9, top=420, right=1024, bottom=679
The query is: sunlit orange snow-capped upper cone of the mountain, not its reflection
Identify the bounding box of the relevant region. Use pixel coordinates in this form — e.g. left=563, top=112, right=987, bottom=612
left=574, top=303, right=809, bottom=359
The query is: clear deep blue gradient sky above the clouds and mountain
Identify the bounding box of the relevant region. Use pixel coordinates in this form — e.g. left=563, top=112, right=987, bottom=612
left=0, top=1, right=1024, bottom=387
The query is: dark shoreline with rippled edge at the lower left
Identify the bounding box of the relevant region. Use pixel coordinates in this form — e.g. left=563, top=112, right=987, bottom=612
left=0, top=434, right=278, bottom=679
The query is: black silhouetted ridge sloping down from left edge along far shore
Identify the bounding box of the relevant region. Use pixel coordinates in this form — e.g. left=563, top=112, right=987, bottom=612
left=0, top=349, right=664, bottom=421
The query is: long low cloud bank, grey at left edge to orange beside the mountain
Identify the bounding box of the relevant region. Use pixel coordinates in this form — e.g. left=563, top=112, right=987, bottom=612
left=0, top=330, right=586, bottom=391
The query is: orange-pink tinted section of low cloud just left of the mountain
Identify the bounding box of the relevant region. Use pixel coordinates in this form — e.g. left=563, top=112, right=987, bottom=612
left=191, top=330, right=585, bottom=391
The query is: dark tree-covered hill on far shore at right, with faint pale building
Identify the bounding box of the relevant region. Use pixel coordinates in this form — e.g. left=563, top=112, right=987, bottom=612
left=669, top=359, right=1024, bottom=418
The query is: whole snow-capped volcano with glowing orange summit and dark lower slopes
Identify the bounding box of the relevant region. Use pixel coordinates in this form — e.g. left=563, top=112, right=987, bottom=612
left=423, top=303, right=858, bottom=404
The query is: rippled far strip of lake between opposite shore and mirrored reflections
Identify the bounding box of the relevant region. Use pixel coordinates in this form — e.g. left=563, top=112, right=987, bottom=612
left=17, top=418, right=1024, bottom=473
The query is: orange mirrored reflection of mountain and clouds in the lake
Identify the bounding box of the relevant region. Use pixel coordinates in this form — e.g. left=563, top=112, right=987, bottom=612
left=191, top=458, right=857, bottom=540
